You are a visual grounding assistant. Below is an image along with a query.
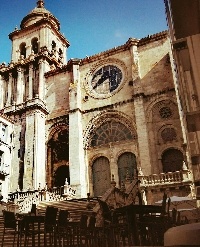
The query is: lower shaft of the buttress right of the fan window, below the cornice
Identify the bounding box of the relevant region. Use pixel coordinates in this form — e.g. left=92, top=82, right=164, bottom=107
left=134, top=96, right=151, bottom=175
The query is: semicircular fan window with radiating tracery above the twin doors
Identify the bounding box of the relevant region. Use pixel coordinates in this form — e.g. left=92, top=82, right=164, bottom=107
left=91, top=120, right=133, bottom=147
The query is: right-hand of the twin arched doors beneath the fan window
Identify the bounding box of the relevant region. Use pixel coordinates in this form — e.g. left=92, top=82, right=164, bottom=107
left=117, top=152, right=137, bottom=186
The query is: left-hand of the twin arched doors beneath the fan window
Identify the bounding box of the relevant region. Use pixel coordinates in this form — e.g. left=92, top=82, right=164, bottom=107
left=92, top=156, right=111, bottom=196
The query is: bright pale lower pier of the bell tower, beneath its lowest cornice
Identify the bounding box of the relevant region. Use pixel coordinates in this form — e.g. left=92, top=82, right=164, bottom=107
left=23, top=110, right=46, bottom=189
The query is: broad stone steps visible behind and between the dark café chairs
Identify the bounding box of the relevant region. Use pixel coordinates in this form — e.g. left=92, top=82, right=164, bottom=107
left=0, top=199, right=97, bottom=247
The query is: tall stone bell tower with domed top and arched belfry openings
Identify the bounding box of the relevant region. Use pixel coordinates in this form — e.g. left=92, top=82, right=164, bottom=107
left=0, top=0, right=69, bottom=191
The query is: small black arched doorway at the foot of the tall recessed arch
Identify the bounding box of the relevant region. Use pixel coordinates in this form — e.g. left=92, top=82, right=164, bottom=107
left=54, top=165, right=70, bottom=187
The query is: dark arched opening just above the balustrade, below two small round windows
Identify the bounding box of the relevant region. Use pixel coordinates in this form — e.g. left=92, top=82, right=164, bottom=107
left=162, top=148, right=184, bottom=172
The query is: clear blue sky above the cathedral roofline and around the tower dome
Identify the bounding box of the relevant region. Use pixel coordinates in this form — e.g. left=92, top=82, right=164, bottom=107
left=0, top=0, right=167, bottom=63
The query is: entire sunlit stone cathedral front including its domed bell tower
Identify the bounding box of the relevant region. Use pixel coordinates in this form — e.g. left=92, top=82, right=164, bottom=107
left=0, top=0, right=192, bottom=202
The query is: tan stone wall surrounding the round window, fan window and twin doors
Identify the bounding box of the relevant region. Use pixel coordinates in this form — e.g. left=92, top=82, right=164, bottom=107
left=66, top=33, right=183, bottom=198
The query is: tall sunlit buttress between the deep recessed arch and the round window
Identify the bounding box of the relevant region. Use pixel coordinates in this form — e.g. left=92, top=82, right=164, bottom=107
left=69, top=59, right=89, bottom=197
